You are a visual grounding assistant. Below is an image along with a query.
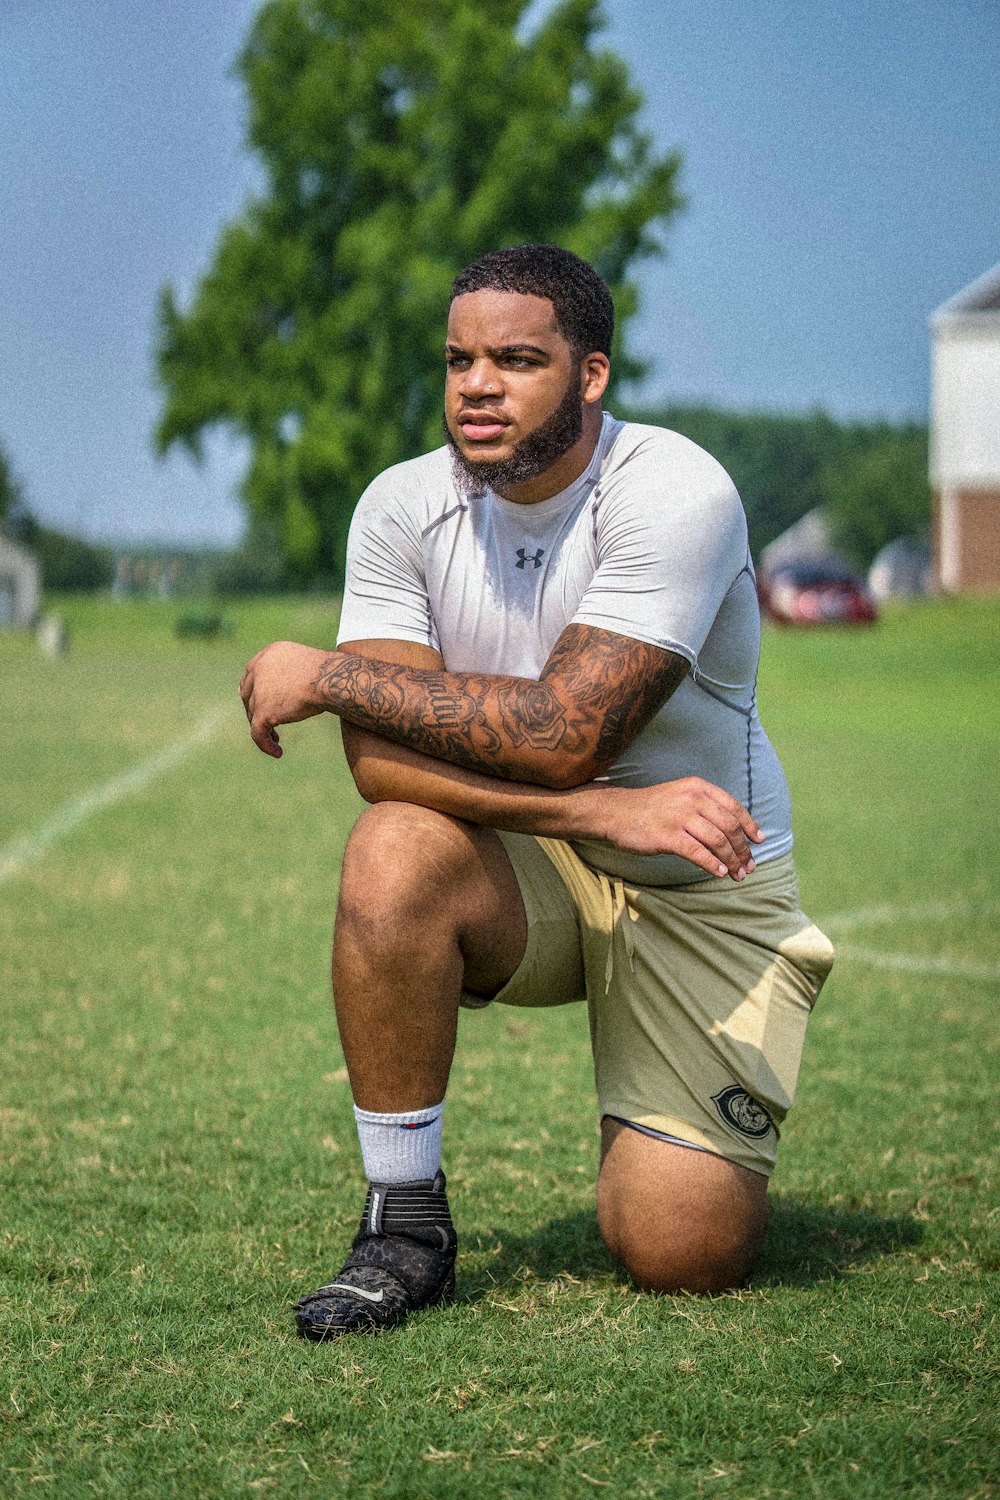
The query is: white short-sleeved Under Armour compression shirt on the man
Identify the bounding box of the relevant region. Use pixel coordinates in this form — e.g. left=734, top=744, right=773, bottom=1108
left=337, top=414, right=792, bottom=885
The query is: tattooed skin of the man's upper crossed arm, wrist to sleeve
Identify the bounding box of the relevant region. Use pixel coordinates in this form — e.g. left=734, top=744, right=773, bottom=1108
left=313, top=626, right=688, bottom=786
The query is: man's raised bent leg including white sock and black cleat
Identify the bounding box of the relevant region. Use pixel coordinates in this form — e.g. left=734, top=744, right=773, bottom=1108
left=297, top=803, right=526, bottom=1340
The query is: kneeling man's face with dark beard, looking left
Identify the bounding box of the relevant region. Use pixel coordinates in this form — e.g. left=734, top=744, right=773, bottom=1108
left=444, top=291, right=583, bottom=494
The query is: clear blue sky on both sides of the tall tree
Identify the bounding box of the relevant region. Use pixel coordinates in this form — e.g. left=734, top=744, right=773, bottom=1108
left=0, top=0, right=1000, bottom=542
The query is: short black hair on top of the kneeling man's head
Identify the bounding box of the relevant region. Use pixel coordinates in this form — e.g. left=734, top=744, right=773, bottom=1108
left=451, top=245, right=615, bottom=359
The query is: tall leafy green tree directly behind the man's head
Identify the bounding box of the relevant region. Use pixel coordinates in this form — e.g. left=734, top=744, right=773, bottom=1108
left=156, top=0, right=679, bottom=579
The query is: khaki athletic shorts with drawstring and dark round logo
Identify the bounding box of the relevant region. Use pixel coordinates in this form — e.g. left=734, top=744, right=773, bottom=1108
left=485, top=834, right=834, bottom=1176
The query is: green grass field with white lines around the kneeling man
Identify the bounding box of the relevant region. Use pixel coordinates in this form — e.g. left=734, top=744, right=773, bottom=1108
left=0, top=600, right=1000, bottom=1500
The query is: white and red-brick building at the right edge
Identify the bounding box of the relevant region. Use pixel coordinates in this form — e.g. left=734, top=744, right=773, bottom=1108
left=931, top=266, right=1000, bottom=593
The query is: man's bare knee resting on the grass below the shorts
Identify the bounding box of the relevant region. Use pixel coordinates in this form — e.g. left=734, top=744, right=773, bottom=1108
left=598, top=1121, right=768, bottom=1293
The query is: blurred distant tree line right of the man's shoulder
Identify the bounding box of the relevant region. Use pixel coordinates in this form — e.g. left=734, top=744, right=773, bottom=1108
left=633, top=407, right=931, bottom=567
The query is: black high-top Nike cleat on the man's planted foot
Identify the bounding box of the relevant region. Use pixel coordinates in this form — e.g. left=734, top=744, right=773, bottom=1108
left=295, top=1172, right=457, bottom=1341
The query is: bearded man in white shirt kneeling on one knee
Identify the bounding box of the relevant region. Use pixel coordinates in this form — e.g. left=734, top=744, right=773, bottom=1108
left=240, top=245, right=832, bottom=1340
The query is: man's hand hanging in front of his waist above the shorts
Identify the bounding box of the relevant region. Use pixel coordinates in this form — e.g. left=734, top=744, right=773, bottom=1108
left=600, top=776, right=763, bottom=881
